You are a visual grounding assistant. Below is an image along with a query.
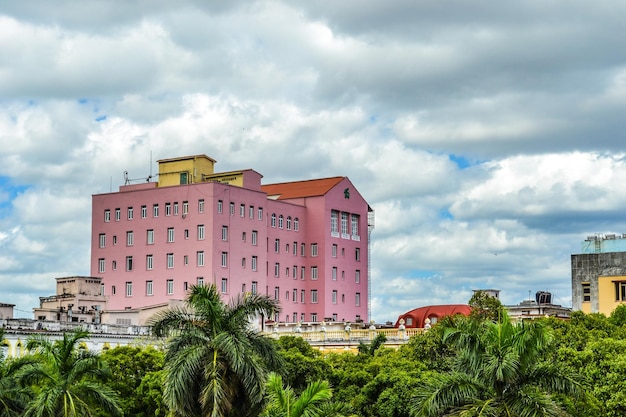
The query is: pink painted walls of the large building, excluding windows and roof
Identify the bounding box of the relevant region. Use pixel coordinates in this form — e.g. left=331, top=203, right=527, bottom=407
left=91, top=176, right=368, bottom=322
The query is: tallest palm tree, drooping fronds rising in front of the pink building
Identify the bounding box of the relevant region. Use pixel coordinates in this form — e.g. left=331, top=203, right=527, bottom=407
left=152, top=285, right=281, bottom=417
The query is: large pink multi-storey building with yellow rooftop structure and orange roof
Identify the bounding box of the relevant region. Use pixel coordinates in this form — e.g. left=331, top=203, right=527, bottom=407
left=91, top=155, right=373, bottom=322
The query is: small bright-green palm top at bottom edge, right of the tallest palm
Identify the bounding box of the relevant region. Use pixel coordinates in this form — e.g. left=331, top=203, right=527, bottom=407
left=262, top=372, right=349, bottom=417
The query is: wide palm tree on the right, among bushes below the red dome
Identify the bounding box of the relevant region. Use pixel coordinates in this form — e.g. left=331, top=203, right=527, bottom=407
left=411, top=313, right=580, bottom=417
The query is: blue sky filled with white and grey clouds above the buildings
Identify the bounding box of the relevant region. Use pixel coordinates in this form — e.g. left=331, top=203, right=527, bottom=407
left=0, top=0, right=626, bottom=322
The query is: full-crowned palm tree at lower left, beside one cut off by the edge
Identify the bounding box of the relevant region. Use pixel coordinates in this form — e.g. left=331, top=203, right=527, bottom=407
left=20, top=331, right=122, bottom=417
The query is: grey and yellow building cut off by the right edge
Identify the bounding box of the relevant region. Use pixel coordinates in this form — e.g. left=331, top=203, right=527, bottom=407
left=571, top=234, right=626, bottom=316
